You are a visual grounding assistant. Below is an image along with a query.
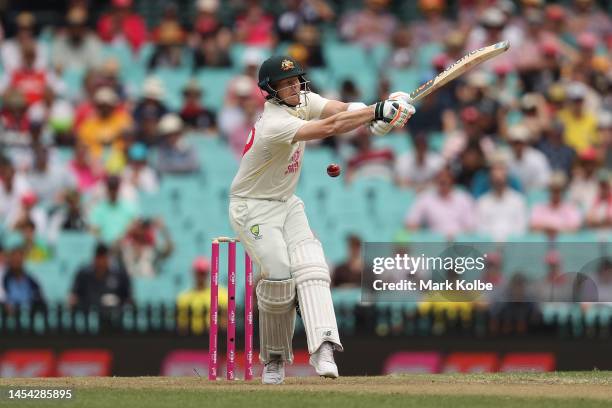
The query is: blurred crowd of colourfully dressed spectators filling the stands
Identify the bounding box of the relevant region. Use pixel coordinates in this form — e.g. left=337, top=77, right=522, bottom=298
left=0, top=0, right=612, bottom=332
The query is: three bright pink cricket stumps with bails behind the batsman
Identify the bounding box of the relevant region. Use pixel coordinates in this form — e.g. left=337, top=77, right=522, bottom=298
left=208, top=237, right=253, bottom=380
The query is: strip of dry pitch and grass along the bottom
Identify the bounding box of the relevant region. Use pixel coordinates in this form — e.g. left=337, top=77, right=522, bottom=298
left=0, top=371, right=612, bottom=408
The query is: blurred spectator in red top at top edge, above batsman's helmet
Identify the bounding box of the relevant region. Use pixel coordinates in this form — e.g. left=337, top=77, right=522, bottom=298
left=236, top=0, right=275, bottom=47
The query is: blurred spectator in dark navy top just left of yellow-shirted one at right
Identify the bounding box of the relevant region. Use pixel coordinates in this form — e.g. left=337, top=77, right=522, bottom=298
left=536, top=119, right=576, bottom=177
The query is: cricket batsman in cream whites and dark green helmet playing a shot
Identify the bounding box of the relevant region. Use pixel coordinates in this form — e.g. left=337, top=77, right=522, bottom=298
left=229, top=56, right=415, bottom=384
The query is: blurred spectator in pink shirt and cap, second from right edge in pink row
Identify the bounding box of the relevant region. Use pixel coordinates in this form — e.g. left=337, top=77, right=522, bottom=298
left=530, top=172, right=582, bottom=238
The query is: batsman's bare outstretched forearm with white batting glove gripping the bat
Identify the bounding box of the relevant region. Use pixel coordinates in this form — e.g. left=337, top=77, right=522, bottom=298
left=293, top=100, right=414, bottom=143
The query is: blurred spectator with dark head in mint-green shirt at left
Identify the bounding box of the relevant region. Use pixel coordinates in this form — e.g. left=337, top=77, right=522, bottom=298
left=88, top=176, right=138, bottom=245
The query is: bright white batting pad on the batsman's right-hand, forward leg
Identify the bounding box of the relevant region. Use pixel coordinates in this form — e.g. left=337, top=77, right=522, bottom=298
left=290, top=239, right=343, bottom=354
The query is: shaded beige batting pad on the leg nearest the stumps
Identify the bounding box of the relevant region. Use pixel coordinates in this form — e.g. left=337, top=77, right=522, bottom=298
left=256, top=279, right=295, bottom=364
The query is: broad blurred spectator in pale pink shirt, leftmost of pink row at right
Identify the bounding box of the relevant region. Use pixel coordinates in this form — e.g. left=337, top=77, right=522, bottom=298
left=406, top=168, right=476, bottom=238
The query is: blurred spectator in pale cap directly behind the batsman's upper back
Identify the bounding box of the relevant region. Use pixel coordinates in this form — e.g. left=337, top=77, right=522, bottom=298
left=219, top=75, right=261, bottom=157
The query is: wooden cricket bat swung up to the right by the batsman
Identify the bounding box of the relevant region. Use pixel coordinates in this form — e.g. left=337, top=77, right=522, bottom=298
left=409, top=41, right=510, bottom=102
